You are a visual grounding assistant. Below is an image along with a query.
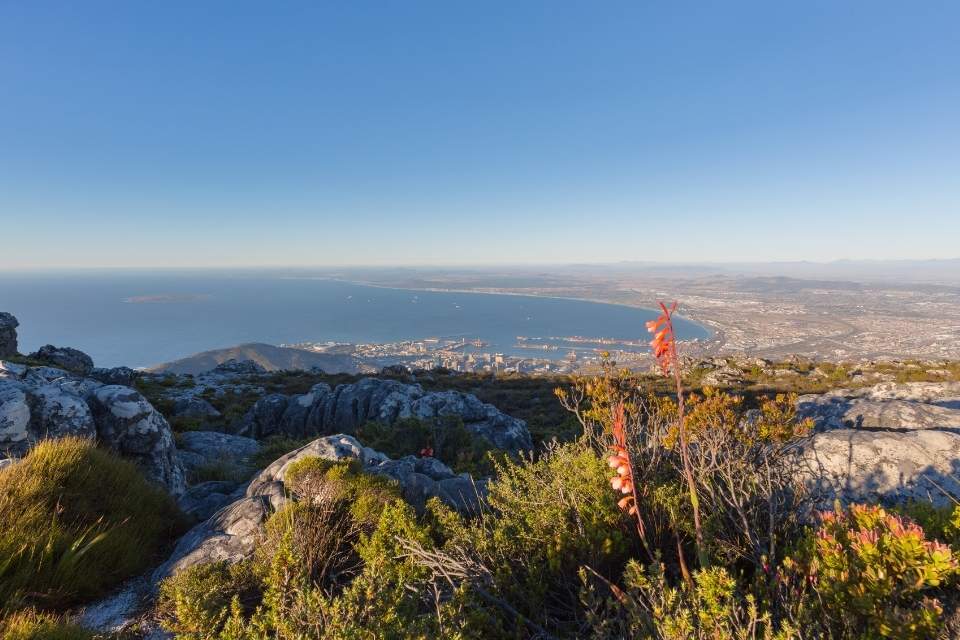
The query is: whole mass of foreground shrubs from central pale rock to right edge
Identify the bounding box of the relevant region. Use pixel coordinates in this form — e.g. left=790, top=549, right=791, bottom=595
left=152, top=368, right=960, bottom=640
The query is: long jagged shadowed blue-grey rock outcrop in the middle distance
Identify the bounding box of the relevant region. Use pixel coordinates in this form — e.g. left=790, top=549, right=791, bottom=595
left=236, top=378, right=532, bottom=451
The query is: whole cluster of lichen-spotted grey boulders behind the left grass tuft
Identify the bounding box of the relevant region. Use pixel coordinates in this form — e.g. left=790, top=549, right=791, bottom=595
left=0, top=362, right=185, bottom=495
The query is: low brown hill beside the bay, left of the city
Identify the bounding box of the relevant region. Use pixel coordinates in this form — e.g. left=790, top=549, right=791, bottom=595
left=149, top=342, right=361, bottom=374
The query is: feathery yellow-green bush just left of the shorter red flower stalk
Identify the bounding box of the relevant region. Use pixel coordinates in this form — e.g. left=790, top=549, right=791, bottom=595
left=432, top=443, right=636, bottom=635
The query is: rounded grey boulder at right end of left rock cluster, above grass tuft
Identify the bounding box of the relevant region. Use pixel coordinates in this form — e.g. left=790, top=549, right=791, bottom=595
left=89, top=385, right=186, bottom=495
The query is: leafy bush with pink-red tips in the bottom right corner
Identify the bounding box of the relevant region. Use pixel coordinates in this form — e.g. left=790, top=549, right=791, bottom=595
left=801, top=505, right=957, bottom=640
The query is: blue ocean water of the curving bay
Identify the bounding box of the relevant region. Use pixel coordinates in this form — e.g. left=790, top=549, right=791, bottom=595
left=0, top=272, right=709, bottom=367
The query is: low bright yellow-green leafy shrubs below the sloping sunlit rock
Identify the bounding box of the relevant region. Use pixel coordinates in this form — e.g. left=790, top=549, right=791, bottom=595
left=158, top=500, right=437, bottom=640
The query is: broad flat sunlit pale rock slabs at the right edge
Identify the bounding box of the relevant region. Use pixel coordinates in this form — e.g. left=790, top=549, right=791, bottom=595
left=797, top=383, right=960, bottom=504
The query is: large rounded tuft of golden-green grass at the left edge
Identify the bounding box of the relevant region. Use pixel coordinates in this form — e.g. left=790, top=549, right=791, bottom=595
left=0, top=438, right=182, bottom=609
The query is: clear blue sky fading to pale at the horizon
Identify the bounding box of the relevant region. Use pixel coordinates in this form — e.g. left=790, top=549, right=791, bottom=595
left=0, top=0, right=960, bottom=269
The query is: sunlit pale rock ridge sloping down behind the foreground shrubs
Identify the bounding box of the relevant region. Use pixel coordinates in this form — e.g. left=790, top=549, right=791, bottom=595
left=159, top=434, right=484, bottom=583
